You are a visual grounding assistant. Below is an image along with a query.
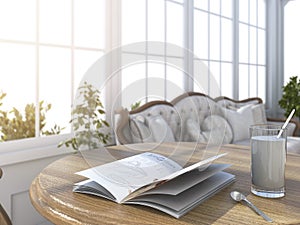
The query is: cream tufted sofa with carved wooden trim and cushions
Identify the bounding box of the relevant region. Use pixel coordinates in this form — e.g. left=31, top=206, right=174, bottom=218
left=115, top=92, right=300, bottom=152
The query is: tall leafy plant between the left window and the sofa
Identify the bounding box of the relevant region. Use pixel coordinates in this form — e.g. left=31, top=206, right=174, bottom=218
left=58, top=82, right=110, bottom=150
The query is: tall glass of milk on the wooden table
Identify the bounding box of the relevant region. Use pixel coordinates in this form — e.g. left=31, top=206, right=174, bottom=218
left=250, top=124, right=287, bottom=198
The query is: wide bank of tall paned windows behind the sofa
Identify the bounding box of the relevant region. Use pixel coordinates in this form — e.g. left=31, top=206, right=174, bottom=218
left=122, top=0, right=266, bottom=106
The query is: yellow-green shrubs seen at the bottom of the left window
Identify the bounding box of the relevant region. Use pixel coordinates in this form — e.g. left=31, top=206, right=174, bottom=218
left=0, top=92, right=63, bottom=141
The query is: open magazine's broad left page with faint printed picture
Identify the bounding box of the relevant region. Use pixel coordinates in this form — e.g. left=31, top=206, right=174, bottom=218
left=76, top=152, right=182, bottom=203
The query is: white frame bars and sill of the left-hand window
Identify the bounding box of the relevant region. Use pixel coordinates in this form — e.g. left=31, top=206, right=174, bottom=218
left=0, top=0, right=111, bottom=166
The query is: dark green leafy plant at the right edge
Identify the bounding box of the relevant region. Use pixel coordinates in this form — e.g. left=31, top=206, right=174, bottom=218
left=278, top=76, right=300, bottom=119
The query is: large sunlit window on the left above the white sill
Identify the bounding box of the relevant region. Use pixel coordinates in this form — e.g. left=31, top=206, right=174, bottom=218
left=0, top=0, right=105, bottom=143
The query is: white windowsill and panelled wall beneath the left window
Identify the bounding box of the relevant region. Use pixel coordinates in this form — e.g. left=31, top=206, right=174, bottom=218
left=0, top=134, right=73, bottom=225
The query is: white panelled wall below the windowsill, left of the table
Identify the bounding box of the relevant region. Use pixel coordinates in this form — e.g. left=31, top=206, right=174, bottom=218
left=0, top=155, right=68, bottom=225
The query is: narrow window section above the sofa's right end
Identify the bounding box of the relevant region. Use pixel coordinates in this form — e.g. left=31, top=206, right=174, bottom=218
left=238, top=0, right=266, bottom=100
